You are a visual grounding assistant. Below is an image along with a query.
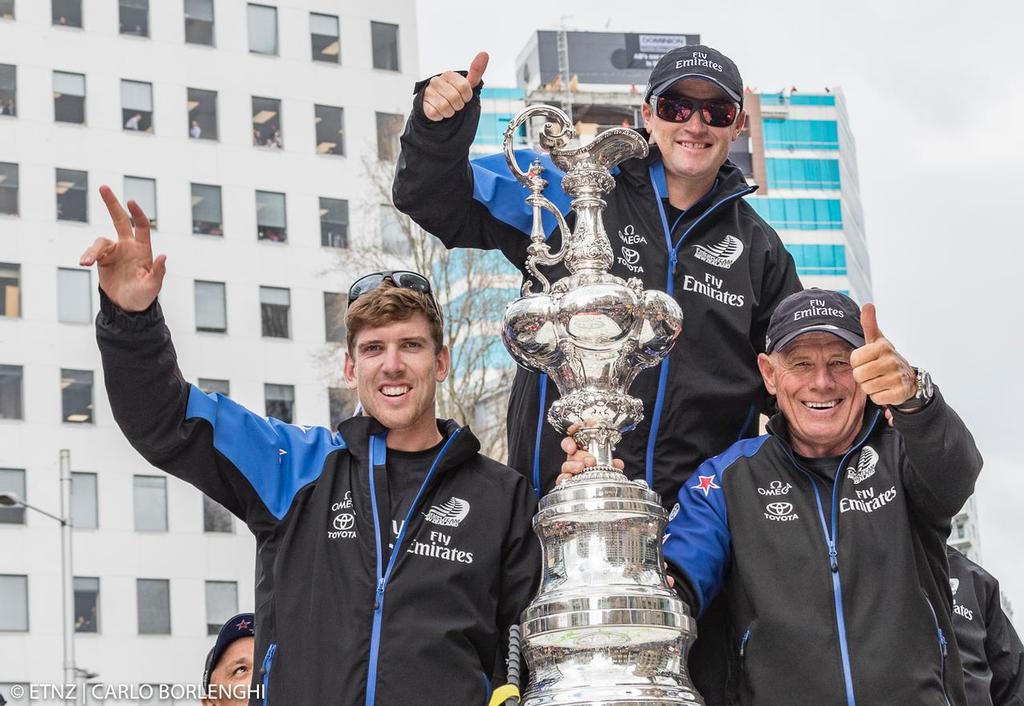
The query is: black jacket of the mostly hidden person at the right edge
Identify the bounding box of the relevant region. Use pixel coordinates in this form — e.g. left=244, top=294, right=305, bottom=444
left=947, top=547, right=1024, bottom=706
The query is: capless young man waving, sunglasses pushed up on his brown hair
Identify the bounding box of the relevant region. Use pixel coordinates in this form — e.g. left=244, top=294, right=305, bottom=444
left=81, top=186, right=541, bottom=706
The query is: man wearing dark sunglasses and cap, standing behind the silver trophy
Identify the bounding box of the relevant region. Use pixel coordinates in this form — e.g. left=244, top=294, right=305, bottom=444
left=394, top=45, right=801, bottom=512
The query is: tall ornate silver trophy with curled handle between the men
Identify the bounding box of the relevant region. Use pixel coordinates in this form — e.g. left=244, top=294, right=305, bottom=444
left=503, top=106, right=703, bottom=706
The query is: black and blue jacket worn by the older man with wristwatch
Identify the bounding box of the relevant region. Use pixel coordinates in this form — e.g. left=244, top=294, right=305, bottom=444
left=665, top=392, right=981, bottom=706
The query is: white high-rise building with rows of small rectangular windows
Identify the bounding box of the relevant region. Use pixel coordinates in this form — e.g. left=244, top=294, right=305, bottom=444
left=0, top=0, right=418, bottom=692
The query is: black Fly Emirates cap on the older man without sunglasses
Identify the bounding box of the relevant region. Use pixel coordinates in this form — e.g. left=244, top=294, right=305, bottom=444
left=765, top=287, right=864, bottom=352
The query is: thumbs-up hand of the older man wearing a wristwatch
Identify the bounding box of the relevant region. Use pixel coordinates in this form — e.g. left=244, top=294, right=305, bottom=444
left=850, top=304, right=918, bottom=406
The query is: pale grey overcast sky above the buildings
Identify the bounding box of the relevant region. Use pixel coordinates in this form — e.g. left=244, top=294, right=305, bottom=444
left=418, top=0, right=1024, bottom=614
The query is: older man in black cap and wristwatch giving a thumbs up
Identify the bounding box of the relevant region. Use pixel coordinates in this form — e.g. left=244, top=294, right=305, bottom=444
left=563, top=289, right=981, bottom=706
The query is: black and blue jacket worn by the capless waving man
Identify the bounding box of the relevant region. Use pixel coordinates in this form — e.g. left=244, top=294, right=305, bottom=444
left=96, top=295, right=540, bottom=706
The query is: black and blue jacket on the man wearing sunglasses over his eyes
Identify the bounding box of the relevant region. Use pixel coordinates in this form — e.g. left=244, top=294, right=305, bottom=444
left=393, top=84, right=801, bottom=504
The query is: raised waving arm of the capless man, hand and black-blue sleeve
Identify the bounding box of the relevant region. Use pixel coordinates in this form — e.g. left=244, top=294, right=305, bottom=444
left=80, top=186, right=344, bottom=532
